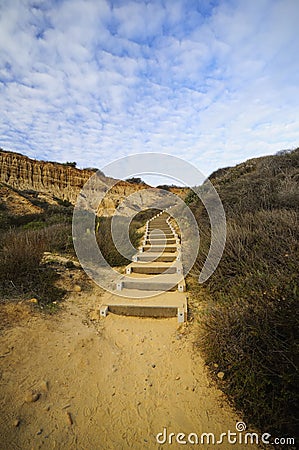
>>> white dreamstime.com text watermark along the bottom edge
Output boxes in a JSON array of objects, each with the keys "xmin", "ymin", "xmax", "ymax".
[{"xmin": 156, "ymin": 422, "xmax": 295, "ymax": 446}]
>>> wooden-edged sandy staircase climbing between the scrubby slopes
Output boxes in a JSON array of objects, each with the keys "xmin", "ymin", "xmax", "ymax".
[{"xmin": 100, "ymin": 210, "xmax": 187, "ymax": 322}]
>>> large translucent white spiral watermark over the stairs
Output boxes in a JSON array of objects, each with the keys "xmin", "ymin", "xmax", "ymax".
[{"xmin": 73, "ymin": 153, "xmax": 226, "ymax": 298}]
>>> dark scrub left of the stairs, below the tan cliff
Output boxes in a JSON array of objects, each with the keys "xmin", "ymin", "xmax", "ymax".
[{"xmin": 0, "ymin": 174, "xmax": 157, "ymax": 306}]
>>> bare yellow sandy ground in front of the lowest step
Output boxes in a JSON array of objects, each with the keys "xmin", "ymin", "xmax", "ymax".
[{"xmin": 0, "ymin": 288, "xmax": 256, "ymax": 450}]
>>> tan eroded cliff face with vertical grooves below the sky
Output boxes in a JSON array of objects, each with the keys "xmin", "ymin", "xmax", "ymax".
[{"xmin": 0, "ymin": 149, "xmax": 190, "ymax": 216}]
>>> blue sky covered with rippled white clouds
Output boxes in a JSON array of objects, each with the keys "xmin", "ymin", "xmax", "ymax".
[{"xmin": 0, "ymin": 0, "xmax": 299, "ymax": 183}]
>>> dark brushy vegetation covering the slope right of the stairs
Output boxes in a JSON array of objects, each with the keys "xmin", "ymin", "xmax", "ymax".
[{"xmin": 186, "ymin": 149, "xmax": 299, "ymax": 437}]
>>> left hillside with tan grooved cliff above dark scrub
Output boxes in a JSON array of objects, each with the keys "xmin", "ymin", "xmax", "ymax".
[{"xmin": 0, "ymin": 150, "xmax": 186, "ymax": 305}]
